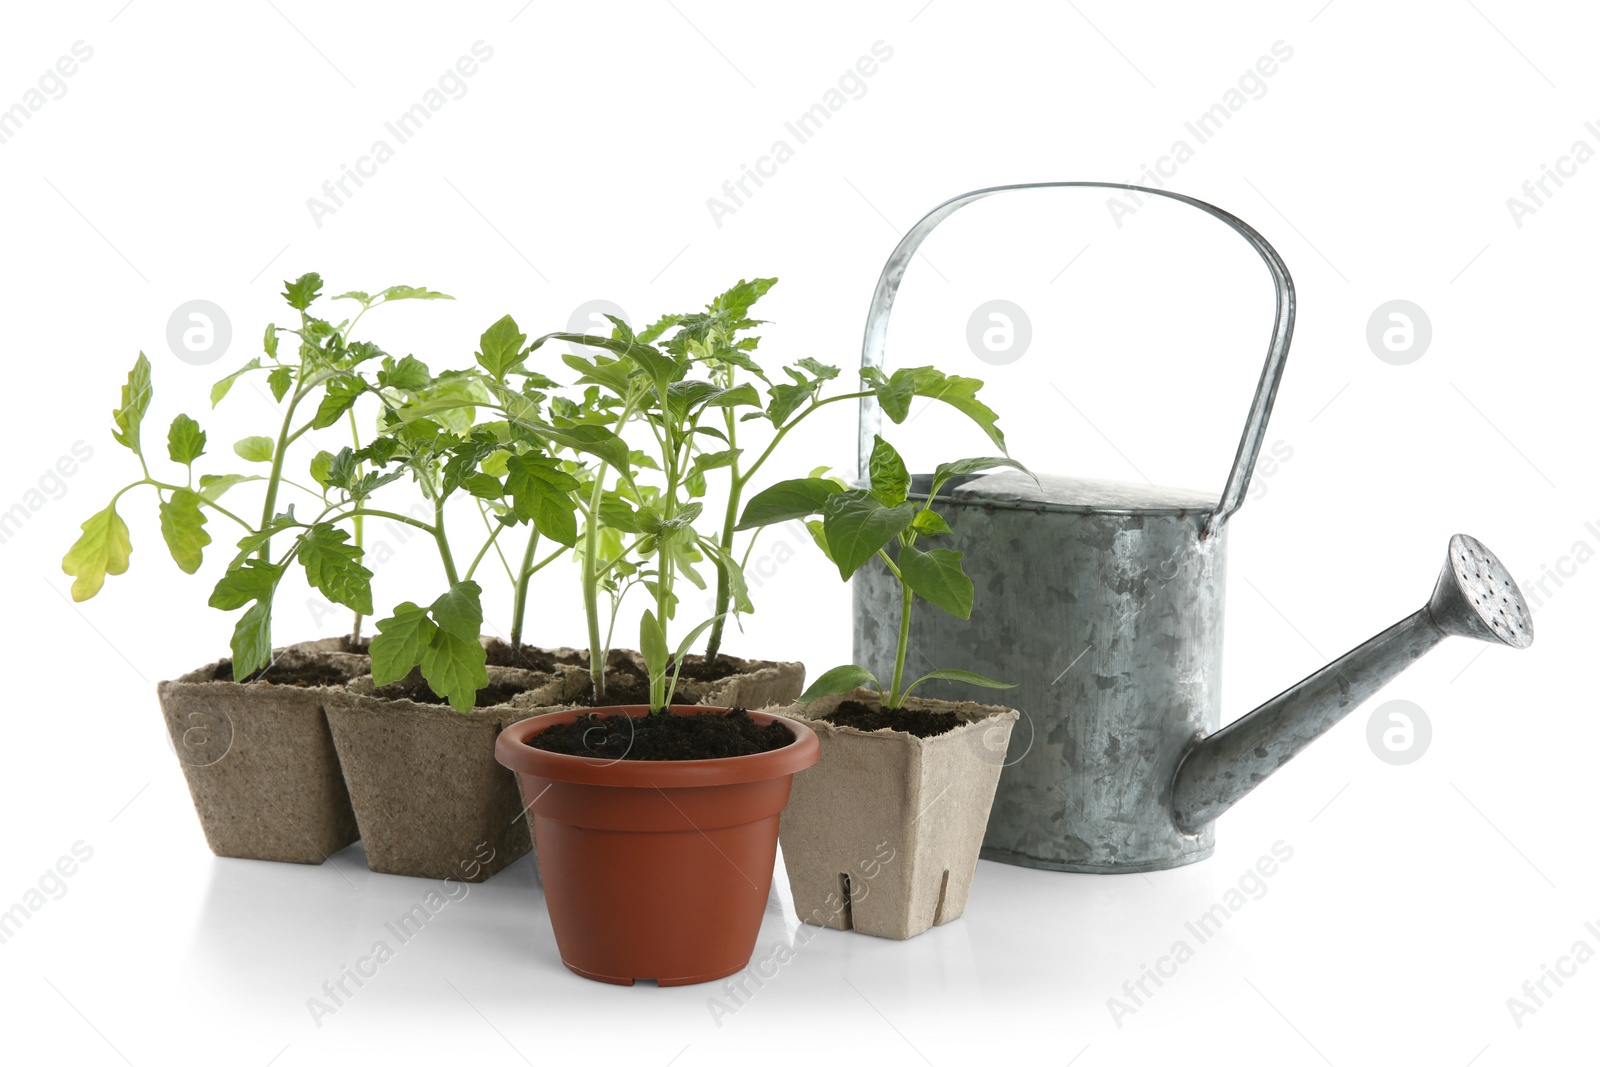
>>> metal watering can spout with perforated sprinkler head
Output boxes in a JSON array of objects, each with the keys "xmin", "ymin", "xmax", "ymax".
[{"xmin": 1173, "ymin": 534, "xmax": 1533, "ymax": 833}]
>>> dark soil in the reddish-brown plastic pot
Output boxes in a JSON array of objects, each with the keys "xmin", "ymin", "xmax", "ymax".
[{"xmin": 528, "ymin": 707, "xmax": 795, "ymax": 760}]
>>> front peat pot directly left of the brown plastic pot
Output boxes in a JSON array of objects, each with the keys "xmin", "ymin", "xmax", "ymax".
[{"xmin": 328, "ymin": 667, "xmax": 563, "ymax": 881}]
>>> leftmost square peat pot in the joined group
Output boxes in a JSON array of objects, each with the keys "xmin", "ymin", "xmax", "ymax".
[{"xmin": 155, "ymin": 638, "xmax": 371, "ymax": 864}]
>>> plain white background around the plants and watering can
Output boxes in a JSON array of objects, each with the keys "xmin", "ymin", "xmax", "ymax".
[{"xmin": 0, "ymin": 0, "xmax": 1600, "ymax": 1067}]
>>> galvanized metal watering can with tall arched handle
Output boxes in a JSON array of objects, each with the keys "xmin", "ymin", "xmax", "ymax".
[{"xmin": 854, "ymin": 182, "xmax": 1533, "ymax": 873}]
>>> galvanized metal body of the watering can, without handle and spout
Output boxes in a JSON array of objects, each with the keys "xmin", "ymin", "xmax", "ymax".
[{"xmin": 854, "ymin": 472, "xmax": 1227, "ymax": 872}]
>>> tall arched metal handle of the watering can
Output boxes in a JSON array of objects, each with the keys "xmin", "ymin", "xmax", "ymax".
[{"xmin": 859, "ymin": 181, "xmax": 1294, "ymax": 536}]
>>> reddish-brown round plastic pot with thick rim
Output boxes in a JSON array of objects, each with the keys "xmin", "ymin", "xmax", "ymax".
[{"xmin": 494, "ymin": 704, "xmax": 818, "ymax": 985}]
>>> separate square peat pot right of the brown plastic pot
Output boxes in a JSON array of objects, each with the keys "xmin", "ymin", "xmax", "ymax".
[{"xmin": 781, "ymin": 689, "xmax": 1019, "ymax": 939}]
